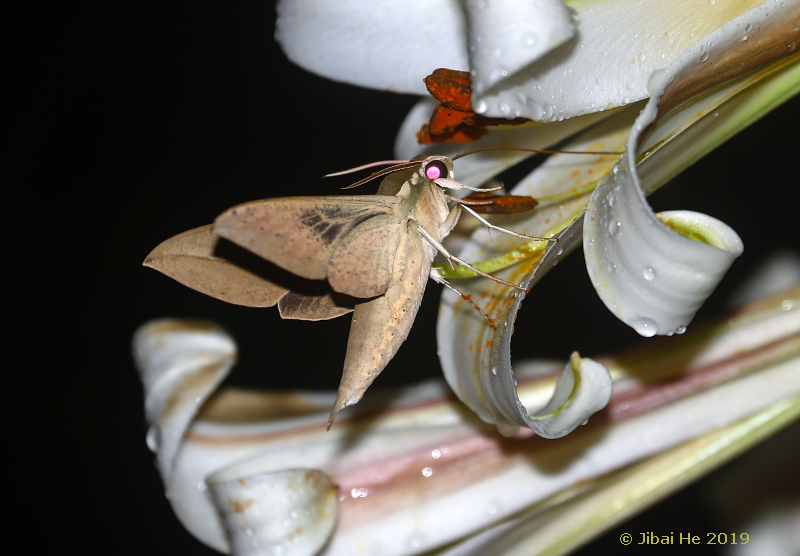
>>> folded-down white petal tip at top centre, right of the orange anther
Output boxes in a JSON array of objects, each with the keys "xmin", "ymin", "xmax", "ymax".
[{"xmin": 464, "ymin": 0, "xmax": 574, "ymax": 102}]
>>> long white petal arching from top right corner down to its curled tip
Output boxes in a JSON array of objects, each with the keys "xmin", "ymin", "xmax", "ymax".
[{"xmin": 584, "ymin": 2, "xmax": 800, "ymax": 336}]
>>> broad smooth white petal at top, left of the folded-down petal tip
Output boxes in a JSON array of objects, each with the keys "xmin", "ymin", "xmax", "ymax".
[{"xmin": 275, "ymin": 0, "xmax": 468, "ymax": 95}]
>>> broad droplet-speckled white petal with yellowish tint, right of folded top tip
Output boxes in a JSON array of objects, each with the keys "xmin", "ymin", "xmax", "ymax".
[{"xmin": 473, "ymin": 0, "xmax": 759, "ymax": 122}]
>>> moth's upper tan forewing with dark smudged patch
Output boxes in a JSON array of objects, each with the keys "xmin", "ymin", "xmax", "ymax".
[{"xmin": 214, "ymin": 195, "xmax": 400, "ymax": 280}]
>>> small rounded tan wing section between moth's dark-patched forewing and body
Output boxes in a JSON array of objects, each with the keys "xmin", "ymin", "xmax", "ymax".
[{"xmin": 328, "ymin": 215, "xmax": 407, "ymax": 297}]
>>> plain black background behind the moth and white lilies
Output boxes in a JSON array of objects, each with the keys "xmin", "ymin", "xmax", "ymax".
[{"xmin": 12, "ymin": 1, "xmax": 800, "ymax": 555}]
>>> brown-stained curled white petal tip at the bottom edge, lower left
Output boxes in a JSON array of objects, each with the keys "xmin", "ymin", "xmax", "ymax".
[{"xmin": 208, "ymin": 465, "xmax": 338, "ymax": 556}]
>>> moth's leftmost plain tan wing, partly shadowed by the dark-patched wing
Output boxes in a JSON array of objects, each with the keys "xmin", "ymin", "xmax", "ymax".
[{"xmin": 144, "ymin": 226, "xmax": 289, "ymax": 307}]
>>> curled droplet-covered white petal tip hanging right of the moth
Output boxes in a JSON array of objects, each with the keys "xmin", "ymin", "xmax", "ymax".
[{"xmin": 584, "ymin": 191, "xmax": 743, "ymax": 337}]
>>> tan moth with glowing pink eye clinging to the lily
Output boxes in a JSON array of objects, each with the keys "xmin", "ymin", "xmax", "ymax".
[{"xmin": 144, "ymin": 149, "xmax": 616, "ymax": 428}]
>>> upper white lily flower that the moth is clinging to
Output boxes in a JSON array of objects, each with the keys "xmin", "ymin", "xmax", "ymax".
[{"xmin": 277, "ymin": 1, "xmax": 800, "ymax": 436}]
